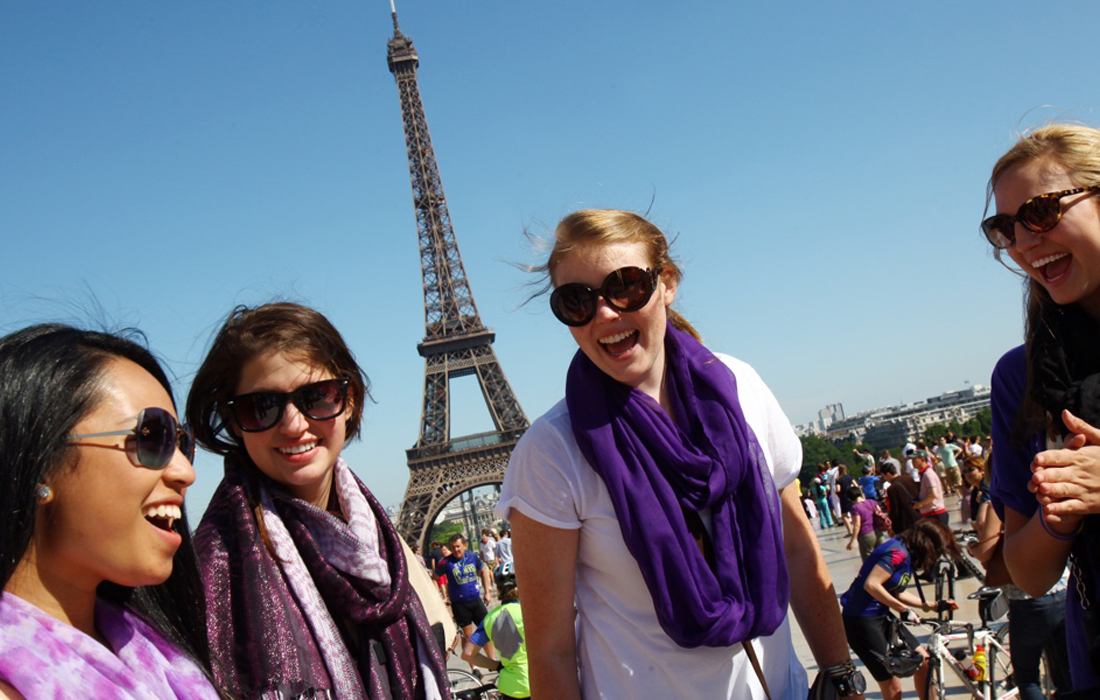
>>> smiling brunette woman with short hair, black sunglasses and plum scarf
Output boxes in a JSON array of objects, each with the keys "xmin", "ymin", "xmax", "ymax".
[{"xmin": 187, "ymin": 303, "xmax": 448, "ymax": 700}]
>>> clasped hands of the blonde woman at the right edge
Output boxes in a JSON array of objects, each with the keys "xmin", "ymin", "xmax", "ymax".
[{"xmin": 1027, "ymin": 411, "xmax": 1100, "ymax": 521}]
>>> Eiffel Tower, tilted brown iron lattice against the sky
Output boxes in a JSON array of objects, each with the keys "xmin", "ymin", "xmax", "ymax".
[{"xmin": 386, "ymin": 8, "xmax": 528, "ymax": 551}]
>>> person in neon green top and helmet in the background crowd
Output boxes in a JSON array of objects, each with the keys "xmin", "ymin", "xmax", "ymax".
[{"xmin": 462, "ymin": 577, "xmax": 531, "ymax": 700}]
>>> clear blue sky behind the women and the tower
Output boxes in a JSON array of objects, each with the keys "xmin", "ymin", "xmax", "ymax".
[{"xmin": 0, "ymin": 0, "xmax": 1100, "ymax": 516}]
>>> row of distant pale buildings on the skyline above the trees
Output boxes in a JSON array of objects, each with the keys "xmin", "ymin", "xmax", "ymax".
[{"xmin": 796, "ymin": 384, "xmax": 989, "ymax": 449}]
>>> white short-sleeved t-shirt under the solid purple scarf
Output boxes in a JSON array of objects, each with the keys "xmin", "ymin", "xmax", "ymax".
[{"xmin": 496, "ymin": 354, "xmax": 807, "ymax": 700}]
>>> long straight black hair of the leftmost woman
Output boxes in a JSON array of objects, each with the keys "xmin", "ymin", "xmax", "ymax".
[{"xmin": 0, "ymin": 324, "xmax": 210, "ymax": 676}]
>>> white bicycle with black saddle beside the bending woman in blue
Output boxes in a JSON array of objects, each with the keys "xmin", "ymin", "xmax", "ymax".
[{"xmin": 909, "ymin": 588, "xmax": 1049, "ymax": 700}]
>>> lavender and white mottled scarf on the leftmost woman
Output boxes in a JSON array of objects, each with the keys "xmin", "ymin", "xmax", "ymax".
[{"xmin": 0, "ymin": 593, "xmax": 218, "ymax": 700}]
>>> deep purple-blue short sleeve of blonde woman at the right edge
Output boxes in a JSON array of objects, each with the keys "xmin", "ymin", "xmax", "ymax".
[{"xmin": 990, "ymin": 346, "xmax": 1040, "ymax": 519}]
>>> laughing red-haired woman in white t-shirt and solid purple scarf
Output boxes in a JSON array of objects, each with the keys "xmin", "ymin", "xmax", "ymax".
[{"xmin": 498, "ymin": 210, "xmax": 862, "ymax": 700}]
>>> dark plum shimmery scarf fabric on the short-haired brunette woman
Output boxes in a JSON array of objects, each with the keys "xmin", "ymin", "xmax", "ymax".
[{"xmin": 195, "ymin": 458, "xmax": 449, "ymax": 700}]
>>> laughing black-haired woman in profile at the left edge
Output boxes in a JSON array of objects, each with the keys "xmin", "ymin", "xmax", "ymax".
[{"xmin": 0, "ymin": 325, "xmax": 218, "ymax": 700}]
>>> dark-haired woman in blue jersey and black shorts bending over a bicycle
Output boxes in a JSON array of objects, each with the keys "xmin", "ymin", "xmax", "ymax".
[{"xmin": 840, "ymin": 518, "xmax": 961, "ymax": 700}]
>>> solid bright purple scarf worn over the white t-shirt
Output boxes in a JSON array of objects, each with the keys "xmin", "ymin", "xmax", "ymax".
[{"xmin": 565, "ymin": 324, "xmax": 790, "ymax": 647}]
